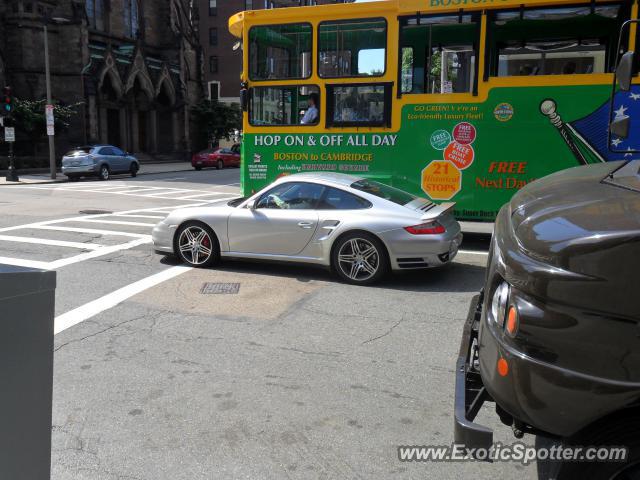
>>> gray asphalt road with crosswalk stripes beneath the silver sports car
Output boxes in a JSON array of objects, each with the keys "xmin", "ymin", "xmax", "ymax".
[{"xmin": 0, "ymin": 169, "xmax": 535, "ymax": 480}]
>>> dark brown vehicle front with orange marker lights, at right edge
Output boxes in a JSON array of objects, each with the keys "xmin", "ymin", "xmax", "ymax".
[{"xmin": 455, "ymin": 26, "xmax": 640, "ymax": 480}]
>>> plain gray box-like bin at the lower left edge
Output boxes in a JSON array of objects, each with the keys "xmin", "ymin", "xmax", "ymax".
[{"xmin": 0, "ymin": 265, "xmax": 56, "ymax": 480}]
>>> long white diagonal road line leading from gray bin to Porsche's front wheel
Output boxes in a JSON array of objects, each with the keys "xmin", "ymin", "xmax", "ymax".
[{"xmin": 53, "ymin": 265, "xmax": 191, "ymax": 335}]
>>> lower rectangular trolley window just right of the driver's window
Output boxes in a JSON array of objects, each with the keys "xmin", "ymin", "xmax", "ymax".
[{"xmin": 327, "ymin": 83, "xmax": 391, "ymax": 127}]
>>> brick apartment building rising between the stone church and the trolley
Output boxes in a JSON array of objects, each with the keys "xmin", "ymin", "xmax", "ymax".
[{"xmin": 198, "ymin": 0, "xmax": 354, "ymax": 102}]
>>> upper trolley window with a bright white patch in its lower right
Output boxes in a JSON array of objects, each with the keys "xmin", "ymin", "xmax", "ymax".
[{"xmin": 318, "ymin": 18, "xmax": 387, "ymax": 78}]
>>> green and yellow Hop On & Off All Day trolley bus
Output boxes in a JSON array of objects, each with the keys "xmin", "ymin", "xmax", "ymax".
[{"xmin": 229, "ymin": 0, "xmax": 640, "ymax": 221}]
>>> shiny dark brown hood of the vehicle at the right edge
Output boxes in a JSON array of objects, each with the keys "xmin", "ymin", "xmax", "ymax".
[{"xmin": 510, "ymin": 161, "xmax": 640, "ymax": 266}]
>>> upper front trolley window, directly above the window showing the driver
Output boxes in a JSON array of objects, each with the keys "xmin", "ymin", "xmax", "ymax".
[{"xmin": 249, "ymin": 23, "xmax": 312, "ymax": 80}]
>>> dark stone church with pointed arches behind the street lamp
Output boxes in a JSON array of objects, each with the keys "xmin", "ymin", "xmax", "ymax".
[{"xmin": 0, "ymin": 0, "xmax": 203, "ymax": 159}]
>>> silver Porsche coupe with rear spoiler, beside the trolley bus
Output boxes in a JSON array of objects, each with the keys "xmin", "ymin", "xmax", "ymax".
[{"xmin": 153, "ymin": 172, "xmax": 462, "ymax": 285}]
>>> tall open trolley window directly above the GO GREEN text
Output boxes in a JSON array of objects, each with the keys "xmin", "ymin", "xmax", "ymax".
[{"xmin": 400, "ymin": 15, "xmax": 478, "ymax": 93}]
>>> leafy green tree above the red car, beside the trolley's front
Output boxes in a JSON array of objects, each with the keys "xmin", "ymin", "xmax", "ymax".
[{"xmin": 191, "ymin": 100, "xmax": 242, "ymax": 146}]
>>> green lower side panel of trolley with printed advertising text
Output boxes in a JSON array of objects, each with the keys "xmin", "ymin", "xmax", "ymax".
[{"xmin": 242, "ymin": 85, "xmax": 640, "ymax": 221}]
